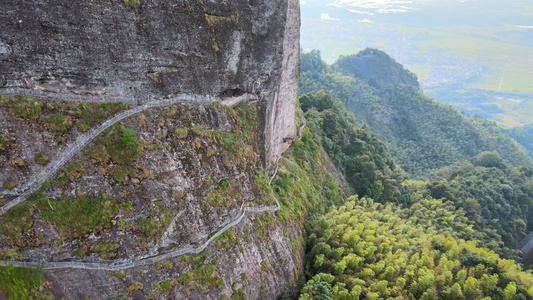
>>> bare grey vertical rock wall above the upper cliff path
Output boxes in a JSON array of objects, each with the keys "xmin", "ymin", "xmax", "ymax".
[{"xmin": 0, "ymin": 0, "xmax": 299, "ymax": 161}]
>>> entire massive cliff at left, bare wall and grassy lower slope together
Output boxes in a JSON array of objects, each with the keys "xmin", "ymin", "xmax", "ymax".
[{"xmin": 0, "ymin": 0, "xmax": 303, "ymax": 299}]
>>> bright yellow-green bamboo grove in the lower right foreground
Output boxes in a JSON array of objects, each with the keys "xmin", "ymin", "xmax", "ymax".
[{"xmin": 300, "ymin": 197, "xmax": 533, "ymax": 300}]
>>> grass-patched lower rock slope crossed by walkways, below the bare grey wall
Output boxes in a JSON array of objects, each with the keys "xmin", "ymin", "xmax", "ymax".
[{"xmin": 0, "ymin": 97, "xmax": 303, "ymax": 299}]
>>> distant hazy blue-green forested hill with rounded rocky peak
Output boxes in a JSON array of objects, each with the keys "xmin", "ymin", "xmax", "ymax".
[{"xmin": 300, "ymin": 49, "xmax": 533, "ymax": 178}]
